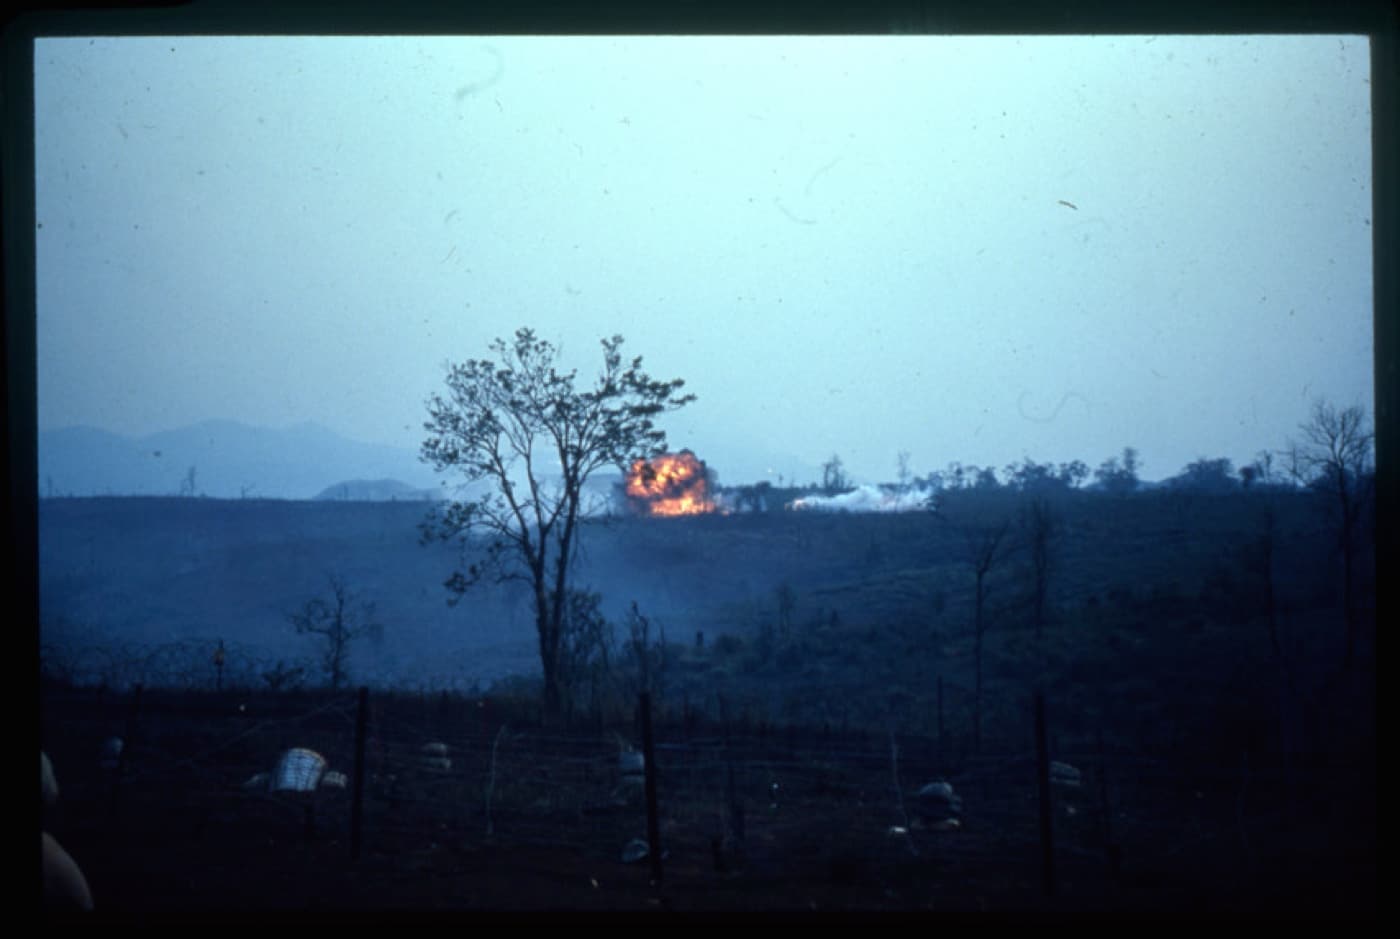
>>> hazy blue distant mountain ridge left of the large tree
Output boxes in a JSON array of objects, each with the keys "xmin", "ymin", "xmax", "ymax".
[{"xmin": 38, "ymin": 420, "xmax": 440, "ymax": 500}]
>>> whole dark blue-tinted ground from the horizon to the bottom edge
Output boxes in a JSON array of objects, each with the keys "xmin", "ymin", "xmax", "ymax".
[{"xmin": 39, "ymin": 491, "xmax": 1378, "ymax": 919}]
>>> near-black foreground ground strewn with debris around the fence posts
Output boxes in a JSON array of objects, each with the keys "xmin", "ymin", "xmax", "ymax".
[{"xmin": 45, "ymin": 689, "xmax": 1376, "ymax": 922}]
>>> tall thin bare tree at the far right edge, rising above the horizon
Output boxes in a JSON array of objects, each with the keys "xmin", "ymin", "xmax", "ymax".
[{"xmin": 1285, "ymin": 399, "xmax": 1375, "ymax": 668}]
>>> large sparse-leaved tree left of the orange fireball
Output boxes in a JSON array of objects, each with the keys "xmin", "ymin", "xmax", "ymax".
[{"xmin": 421, "ymin": 329, "xmax": 694, "ymax": 716}]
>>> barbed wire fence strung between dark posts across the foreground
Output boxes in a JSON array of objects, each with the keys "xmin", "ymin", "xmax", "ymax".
[{"xmin": 38, "ymin": 671, "xmax": 1336, "ymax": 901}]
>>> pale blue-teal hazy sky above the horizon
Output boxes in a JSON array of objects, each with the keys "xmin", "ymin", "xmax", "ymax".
[{"xmin": 35, "ymin": 35, "xmax": 1373, "ymax": 483}]
